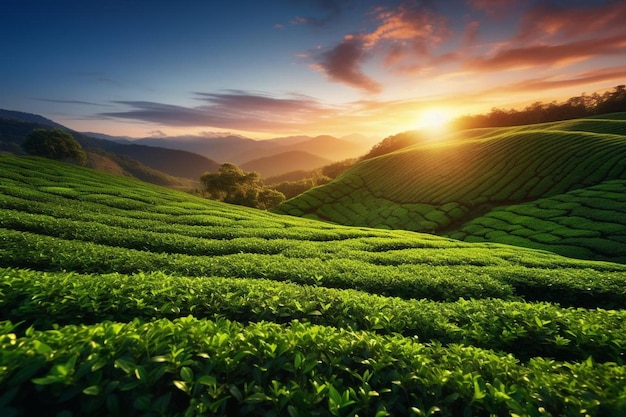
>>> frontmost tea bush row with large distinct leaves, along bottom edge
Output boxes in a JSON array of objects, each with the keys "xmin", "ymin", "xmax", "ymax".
[{"xmin": 0, "ymin": 317, "xmax": 626, "ymax": 417}]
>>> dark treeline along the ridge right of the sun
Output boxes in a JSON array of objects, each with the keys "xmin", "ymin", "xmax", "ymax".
[{"xmin": 453, "ymin": 85, "xmax": 626, "ymax": 129}]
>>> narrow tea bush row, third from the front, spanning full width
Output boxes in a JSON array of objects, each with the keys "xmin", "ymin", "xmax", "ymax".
[{"xmin": 0, "ymin": 229, "xmax": 626, "ymax": 308}]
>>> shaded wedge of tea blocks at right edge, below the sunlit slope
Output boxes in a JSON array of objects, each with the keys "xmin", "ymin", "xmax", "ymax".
[{"xmin": 448, "ymin": 180, "xmax": 626, "ymax": 263}]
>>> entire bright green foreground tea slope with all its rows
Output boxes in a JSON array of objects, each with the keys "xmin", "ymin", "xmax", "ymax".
[{"xmin": 0, "ymin": 155, "xmax": 626, "ymax": 416}]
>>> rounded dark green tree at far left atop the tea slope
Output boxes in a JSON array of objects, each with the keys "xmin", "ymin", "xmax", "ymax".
[{"xmin": 22, "ymin": 129, "xmax": 87, "ymax": 165}]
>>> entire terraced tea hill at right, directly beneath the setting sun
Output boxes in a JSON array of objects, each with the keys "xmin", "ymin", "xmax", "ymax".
[{"xmin": 276, "ymin": 113, "xmax": 626, "ymax": 262}]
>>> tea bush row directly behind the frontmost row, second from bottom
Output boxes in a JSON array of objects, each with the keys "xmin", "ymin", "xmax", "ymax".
[{"xmin": 0, "ymin": 269, "xmax": 626, "ymax": 362}]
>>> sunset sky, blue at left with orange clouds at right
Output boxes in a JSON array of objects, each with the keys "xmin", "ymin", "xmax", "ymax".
[{"xmin": 0, "ymin": 0, "xmax": 626, "ymax": 139}]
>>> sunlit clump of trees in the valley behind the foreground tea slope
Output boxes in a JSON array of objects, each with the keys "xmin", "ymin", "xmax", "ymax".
[{"xmin": 200, "ymin": 163, "xmax": 285, "ymax": 209}]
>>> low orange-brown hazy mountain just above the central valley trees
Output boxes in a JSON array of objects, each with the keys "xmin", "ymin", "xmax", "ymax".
[{"xmin": 241, "ymin": 151, "xmax": 332, "ymax": 178}]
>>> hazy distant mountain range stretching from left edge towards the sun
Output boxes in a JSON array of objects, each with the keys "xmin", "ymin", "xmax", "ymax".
[{"xmin": 0, "ymin": 110, "xmax": 375, "ymax": 181}]
